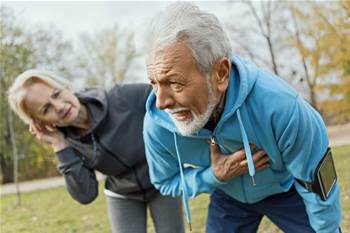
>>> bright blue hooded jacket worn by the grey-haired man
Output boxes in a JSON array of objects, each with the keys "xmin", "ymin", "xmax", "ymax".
[{"xmin": 144, "ymin": 57, "xmax": 341, "ymax": 233}]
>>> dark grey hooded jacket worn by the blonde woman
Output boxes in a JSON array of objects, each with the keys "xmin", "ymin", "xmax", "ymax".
[{"xmin": 57, "ymin": 84, "xmax": 157, "ymax": 204}]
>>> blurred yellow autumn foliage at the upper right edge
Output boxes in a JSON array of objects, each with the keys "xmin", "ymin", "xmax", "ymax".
[{"xmin": 290, "ymin": 1, "xmax": 350, "ymax": 123}]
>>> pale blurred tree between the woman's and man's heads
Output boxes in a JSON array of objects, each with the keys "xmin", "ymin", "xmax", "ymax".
[{"xmin": 75, "ymin": 25, "xmax": 139, "ymax": 88}]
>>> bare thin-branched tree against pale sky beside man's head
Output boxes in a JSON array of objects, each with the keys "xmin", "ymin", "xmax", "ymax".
[{"xmin": 228, "ymin": 1, "xmax": 294, "ymax": 78}]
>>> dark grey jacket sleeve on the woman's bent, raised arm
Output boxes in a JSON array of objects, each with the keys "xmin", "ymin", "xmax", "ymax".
[{"xmin": 56, "ymin": 146, "xmax": 98, "ymax": 204}]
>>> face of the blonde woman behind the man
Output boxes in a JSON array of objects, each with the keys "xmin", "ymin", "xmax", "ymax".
[{"xmin": 23, "ymin": 81, "xmax": 80, "ymax": 127}]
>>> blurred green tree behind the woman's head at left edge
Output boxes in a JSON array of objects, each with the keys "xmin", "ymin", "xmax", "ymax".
[{"xmin": 0, "ymin": 5, "xmax": 71, "ymax": 183}]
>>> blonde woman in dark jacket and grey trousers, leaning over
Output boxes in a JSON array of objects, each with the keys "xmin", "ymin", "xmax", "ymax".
[{"xmin": 8, "ymin": 70, "xmax": 184, "ymax": 233}]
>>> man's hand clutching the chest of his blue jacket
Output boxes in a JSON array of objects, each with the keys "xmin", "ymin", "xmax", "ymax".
[{"xmin": 210, "ymin": 144, "xmax": 269, "ymax": 181}]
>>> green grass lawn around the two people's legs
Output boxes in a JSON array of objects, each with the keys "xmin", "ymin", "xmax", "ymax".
[{"xmin": 0, "ymin": 145, "xmax": 350, "ymax": 233}]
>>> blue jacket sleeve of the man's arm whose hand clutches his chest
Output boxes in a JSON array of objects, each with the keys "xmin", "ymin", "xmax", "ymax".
[{"xmin": 143, "ymin": 114, "xmax": 223, "ymax": 198}]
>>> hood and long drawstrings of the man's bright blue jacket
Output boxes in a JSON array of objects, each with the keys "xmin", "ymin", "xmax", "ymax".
[{"xmin": 146, "ymin": 56, "xmax": 258, "ymax": 228}]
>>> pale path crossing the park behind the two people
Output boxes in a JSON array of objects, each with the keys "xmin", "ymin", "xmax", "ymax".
[{"xmin": 0, "ymin": 123, "xmax": 350, "ymax": 196}]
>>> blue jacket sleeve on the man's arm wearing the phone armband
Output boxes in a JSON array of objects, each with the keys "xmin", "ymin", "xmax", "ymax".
[{"xmin": 272, "ymin": 97, "xmax": 341, "ymax": 233}]
